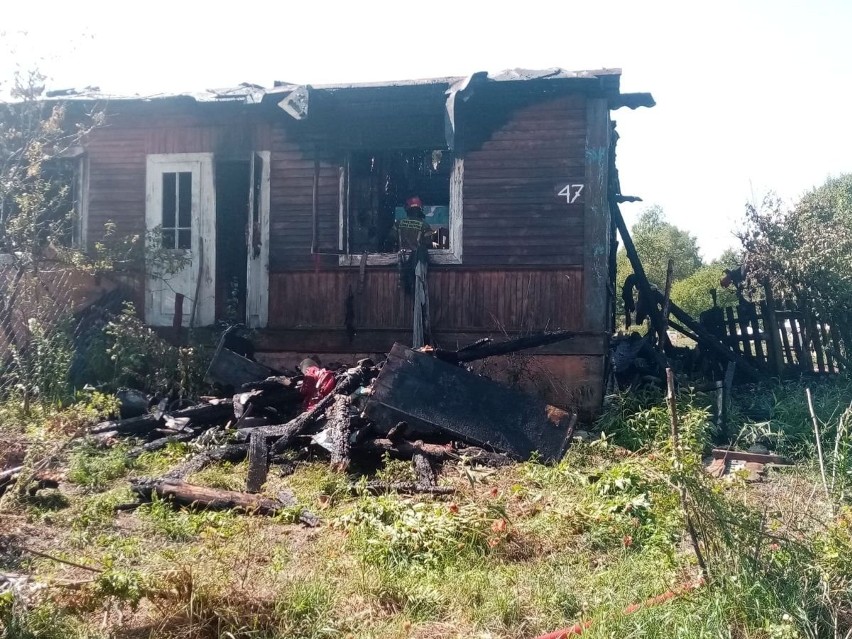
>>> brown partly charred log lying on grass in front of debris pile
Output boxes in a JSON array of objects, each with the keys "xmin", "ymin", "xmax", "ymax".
[{"xmin": 130, "ymin": 479, "xmax": 292, "ymax": 515}]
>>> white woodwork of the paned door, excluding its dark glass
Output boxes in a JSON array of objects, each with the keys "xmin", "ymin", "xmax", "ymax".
[{"xmin": 145, "ymin": 153, "xmax": 216, "ymax": 326}]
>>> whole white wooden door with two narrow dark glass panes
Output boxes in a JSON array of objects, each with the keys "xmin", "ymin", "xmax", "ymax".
[{"xmin": 145, "ymin": 153, "xmax": 216, "ymax": 326}]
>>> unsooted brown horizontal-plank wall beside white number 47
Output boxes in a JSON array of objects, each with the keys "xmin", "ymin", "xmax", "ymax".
[{"xmin": 463, "ymin": 96, "xmax": 586, "ymax": 266}]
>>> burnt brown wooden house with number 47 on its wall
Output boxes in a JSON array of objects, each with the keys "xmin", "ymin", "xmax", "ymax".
[{"xmin": 62, "ymin": 69, "xmax": 653, "ymax": 412}]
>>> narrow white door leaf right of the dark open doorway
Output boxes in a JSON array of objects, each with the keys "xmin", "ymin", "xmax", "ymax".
[{"xmin": 246, "ymin": 151, "xmax": 270, "ymax": 328}]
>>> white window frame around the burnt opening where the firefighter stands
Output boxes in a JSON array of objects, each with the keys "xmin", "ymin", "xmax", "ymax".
[{"xmin": 338, "ymin": 158, "xmax": 464, "ymax": 266}]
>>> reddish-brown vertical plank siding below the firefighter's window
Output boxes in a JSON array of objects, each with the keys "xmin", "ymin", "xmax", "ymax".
[{"xmin": 269, "ymin": 267, "xmax": 583, "ymax": 333}]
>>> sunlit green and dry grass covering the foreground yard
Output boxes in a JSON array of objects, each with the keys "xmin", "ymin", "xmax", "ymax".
[{"xmin": 0, "ymin": 384, "xmax": 852, "ymax": 639}]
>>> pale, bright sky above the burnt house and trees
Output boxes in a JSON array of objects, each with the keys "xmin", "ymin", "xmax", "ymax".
[{"xmin": 0, "ymin": 0, "xmax": 852, "ymax": 258}]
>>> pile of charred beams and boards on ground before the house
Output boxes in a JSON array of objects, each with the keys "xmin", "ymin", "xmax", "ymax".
[{"xmin": 81, "ymin": 331, "xmax": 577, "ymax": 525}]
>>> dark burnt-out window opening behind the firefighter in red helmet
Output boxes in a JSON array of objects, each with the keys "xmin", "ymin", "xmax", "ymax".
[{"xmin": 348, "ymin": 149, "xmax": 454, "ymax": 254}]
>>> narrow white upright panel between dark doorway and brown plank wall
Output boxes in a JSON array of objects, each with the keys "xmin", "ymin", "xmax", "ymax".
[{"xmin": 246, "ymin": 151, "xmax": 272, "ymax": 328}]
